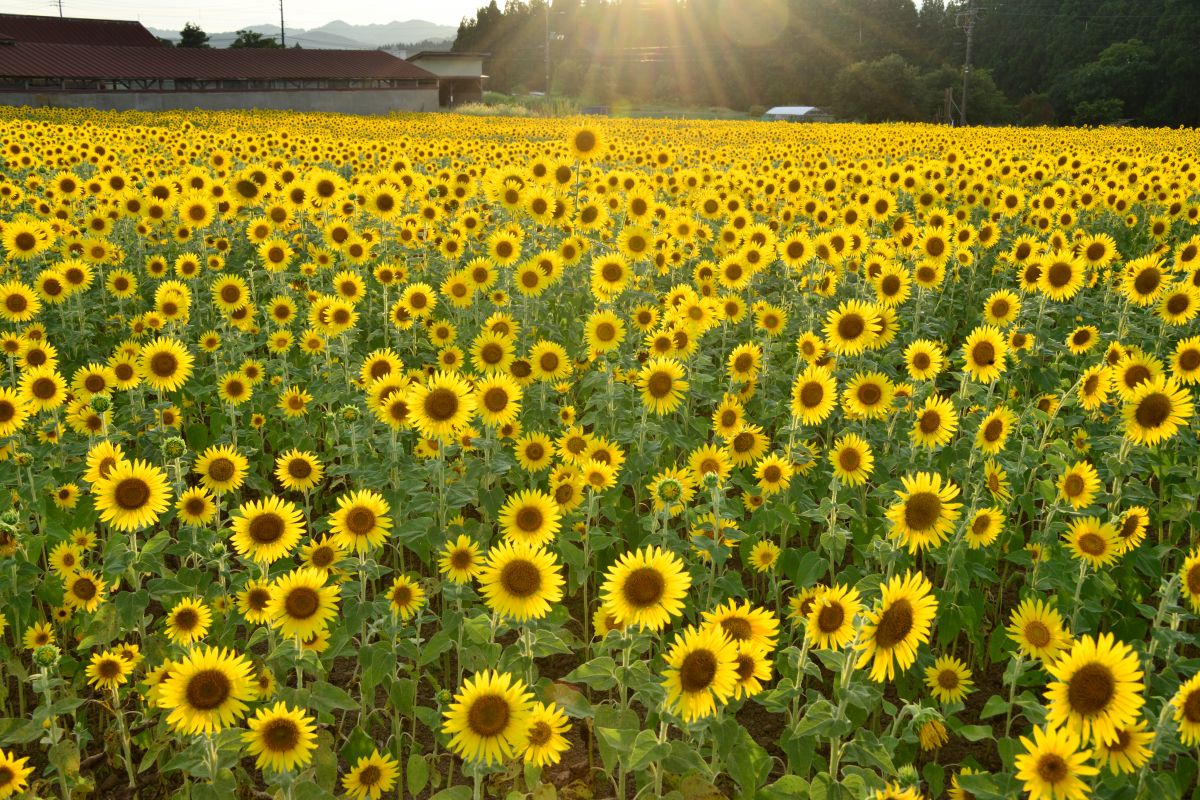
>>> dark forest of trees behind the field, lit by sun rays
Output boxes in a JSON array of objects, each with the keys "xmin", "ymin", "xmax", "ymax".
[{"xmin": 455, "ymin": 0, "xmax": 1200, "ymax": 125}]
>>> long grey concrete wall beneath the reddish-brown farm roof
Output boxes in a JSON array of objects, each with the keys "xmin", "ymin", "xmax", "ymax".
[{"xmin": 0, "ymin": 88, "xmax": 438, "ymax": 114}]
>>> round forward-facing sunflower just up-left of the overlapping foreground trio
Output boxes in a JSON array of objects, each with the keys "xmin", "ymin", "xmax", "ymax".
[{"xmin": 600, "ymin": 547, "xmax": 691, "ymax": 631}]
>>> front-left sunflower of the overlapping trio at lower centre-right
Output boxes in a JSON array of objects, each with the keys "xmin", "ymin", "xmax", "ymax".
[{"xmin": 662, "ymin": 626, "xmax": 738, "ymax": 722}]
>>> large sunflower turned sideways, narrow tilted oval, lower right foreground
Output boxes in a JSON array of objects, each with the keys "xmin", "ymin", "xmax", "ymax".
[{"xmin": 857, "ymin": 571, "xmax": 937, "ymax": 682}]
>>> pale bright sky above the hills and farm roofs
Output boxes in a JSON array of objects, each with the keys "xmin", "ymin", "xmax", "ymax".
[{"xmin": 0, "ymin": 0, "xmax": 487, "ymax": 32}]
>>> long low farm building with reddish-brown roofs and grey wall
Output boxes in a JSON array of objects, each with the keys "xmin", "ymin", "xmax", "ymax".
[{"xmin": 0, "ymin": 14, "xmax": 438, "ymax": 114}]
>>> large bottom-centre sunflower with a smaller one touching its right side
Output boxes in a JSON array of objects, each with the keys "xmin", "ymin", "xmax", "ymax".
[{"xmin": 442, "ymin": 669, "xmax": 533, "ymax": 764}]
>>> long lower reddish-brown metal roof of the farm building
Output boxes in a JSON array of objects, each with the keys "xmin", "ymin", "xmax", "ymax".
[{"xmin": 0, "ymin": 42, "xmax": 437, "ymax": 80}]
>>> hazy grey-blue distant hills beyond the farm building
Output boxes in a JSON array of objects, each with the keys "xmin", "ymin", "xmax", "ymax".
[{"xmin": 150, "ymin": 19, "xmax": 458, "ymax": 50}]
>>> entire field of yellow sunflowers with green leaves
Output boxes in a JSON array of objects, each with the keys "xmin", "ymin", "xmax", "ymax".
[{"xmin": 0, "ymin": 108, "xmax": 1200, "ymax": 800}]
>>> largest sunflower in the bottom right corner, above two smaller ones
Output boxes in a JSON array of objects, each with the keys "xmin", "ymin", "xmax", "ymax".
[{"xmin": 1046, "ymin": 633, "xmax": 1144, "ymax": 744}]
